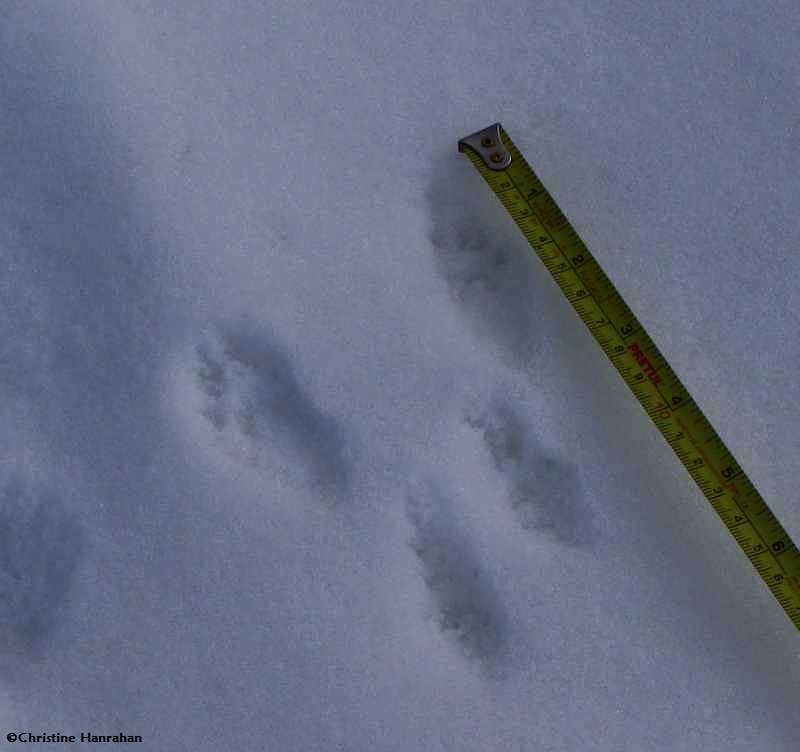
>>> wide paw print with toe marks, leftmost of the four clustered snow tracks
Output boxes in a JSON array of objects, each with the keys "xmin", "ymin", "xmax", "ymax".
[{"xmin": 193, "ymin": 319, "xmax": 350, "ymax": 494}]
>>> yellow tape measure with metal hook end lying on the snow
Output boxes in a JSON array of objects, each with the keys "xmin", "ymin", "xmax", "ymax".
[{"xmin": 458, "ymin": 123, "xmax": 800, "ymax": 629}]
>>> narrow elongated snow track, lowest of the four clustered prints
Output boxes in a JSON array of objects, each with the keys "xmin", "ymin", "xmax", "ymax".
[{"xmin": 406, "ymin": 484, "xmax": 508, "ymax": 673}]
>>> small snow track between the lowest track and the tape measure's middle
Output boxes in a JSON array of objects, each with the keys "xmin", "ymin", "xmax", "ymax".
[{"xmin": 467, "ymin": 399, "xmax": 594, "ymax": 547}]
